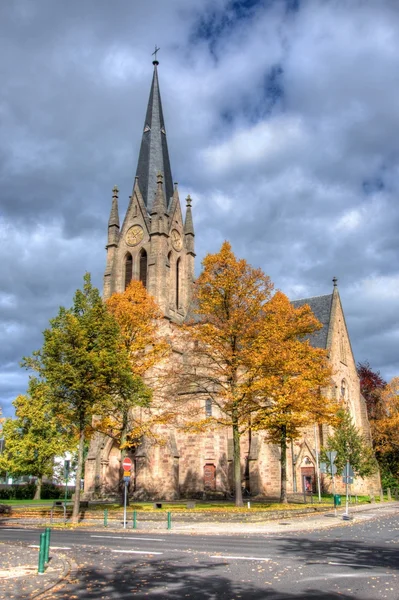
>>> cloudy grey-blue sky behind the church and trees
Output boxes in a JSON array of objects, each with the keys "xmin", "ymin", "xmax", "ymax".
[{"xmin": 0, "ymin": 0, "xmax": 399, "ymax": 415}]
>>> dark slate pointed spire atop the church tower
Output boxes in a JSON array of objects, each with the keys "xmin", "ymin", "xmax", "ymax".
[{"xmin": 136, "ymin": 60, "xmax": 173, "ymax": 213}]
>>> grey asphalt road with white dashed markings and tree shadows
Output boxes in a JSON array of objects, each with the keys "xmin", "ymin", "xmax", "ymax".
[{"xmin": 0, "ymin": 509, "xmax": 399, "ymax": 600}]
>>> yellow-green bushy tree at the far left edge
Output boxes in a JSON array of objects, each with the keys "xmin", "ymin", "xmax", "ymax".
[{"xmin": 0, "ymin": 378, "xmax": 74, "ymax": 500}]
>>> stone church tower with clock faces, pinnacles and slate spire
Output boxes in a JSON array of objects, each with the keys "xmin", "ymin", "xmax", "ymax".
[{"xmin": 104, "ymin": 60, "xmax": 195, "ymax": 322}]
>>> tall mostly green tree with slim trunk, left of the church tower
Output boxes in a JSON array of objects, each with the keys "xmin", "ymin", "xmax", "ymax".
[{"xmin": 24, "ymin": 274, "xmax": 142, "ymax": 522}]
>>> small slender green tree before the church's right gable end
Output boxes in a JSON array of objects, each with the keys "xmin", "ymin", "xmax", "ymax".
[{"xmin": 321, "ymin": 408, "xmax": 378, "ymax": 478}]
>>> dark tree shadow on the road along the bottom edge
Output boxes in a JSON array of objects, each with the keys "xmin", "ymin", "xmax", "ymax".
[{"xmin": 50, "ymin": 559, "xmax": 368, "ymax": 600}]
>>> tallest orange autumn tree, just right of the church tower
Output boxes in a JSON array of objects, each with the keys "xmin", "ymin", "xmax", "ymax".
[{"xmin": 176, "ymin": 242, "xmax": 273, "ymax": 506}]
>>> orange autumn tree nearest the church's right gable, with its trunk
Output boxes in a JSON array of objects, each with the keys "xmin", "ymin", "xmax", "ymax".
[{"xmin": 250, "ymin": 292, "xmax": 337, "ymax": 503}]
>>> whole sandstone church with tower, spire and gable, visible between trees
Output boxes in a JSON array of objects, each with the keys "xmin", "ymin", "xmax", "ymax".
[{"xmin": 84, "ymin": 60, "xmax": 379, "ymax": 500}]
